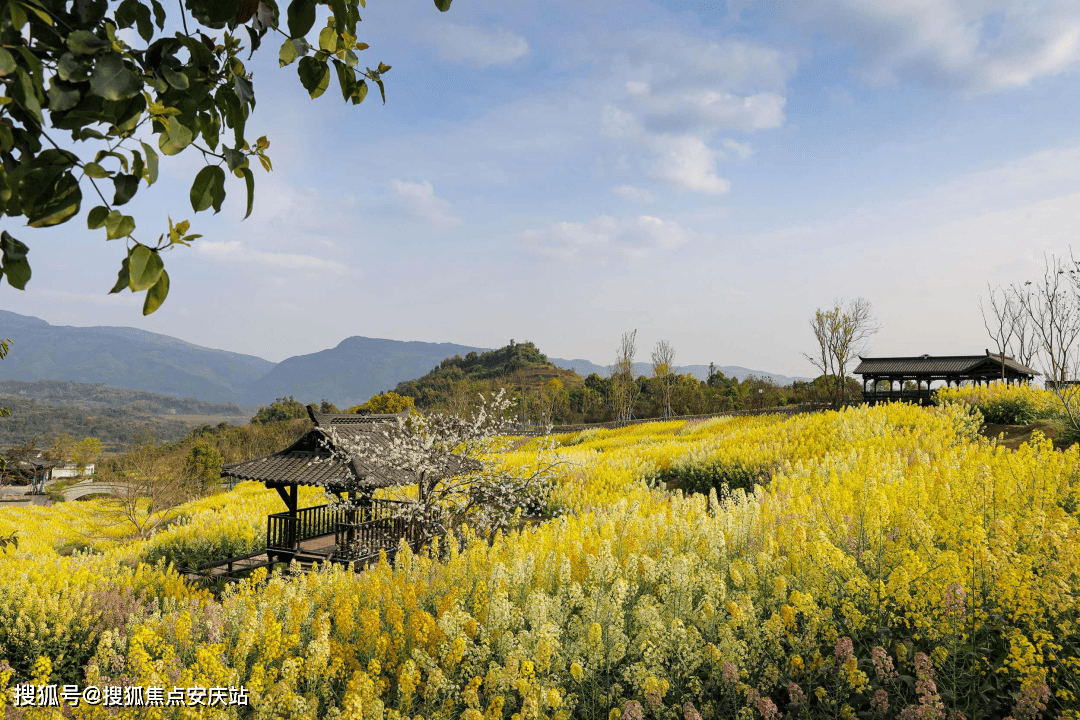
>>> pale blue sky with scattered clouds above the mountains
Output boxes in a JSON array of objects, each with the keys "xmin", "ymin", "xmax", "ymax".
[{"xmin": 6, "ymin": 0, "xmax": 1080, "ymax": 375}]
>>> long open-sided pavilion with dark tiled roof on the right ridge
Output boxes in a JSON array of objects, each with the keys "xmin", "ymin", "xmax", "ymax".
[{"xmin": 854, "ymin": 350, "xmax": 1039, "ymax": 405}]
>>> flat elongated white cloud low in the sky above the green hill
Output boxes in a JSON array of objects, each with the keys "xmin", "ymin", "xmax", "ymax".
[{"xmin": 519, "ymin": 215, "xmax": 696, "ymax": 259}]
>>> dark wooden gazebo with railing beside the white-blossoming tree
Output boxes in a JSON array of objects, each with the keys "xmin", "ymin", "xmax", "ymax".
[{"xmin": 221, "ymin": 408, "xmax": 426, "ymax": 567}]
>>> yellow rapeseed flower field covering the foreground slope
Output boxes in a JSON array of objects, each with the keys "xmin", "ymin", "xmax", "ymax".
[{"xmin": 0, "ymin": 404, "xmax": 1080, "ymax": 720}]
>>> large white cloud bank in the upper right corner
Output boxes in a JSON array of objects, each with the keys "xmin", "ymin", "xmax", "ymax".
[{"xmin": 792, "ymin": 0, "xmax": 1080, "ymax": 93}]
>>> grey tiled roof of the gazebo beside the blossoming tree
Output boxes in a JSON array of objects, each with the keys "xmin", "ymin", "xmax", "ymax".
[{"xmin": 221, "ymin": 408, "xmax": 425, "ymax": 490}]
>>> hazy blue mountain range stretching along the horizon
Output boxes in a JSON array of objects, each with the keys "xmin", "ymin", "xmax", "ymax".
[{"xmin": 0, "ymin": 310, "xmax": 799, "ymax": 407}]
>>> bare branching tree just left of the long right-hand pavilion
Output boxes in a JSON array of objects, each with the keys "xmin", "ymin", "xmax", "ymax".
[{"xmin": 804, "ymin": 298, "xmax": 881, "ymax": 405}]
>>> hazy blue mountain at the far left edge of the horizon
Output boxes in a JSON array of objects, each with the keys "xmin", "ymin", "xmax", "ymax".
[{"xmin": 0, "ymin": 310, "xmax": 274, "ymax": 403}]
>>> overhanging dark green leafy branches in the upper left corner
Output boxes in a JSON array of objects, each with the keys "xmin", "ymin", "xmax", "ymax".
[{"xmin": 0, "ymin": 0, "xmax": 450, "ymax": 314}]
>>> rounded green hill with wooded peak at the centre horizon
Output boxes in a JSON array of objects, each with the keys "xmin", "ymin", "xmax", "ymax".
[{"xmin": 395, "ymin": 340, "xmax": 583, "ymax": 407}]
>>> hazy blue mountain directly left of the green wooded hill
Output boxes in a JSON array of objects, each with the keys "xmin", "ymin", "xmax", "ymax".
[{"xmin": 243, "ymin": 336, "xmax": 483, "ymax": 407}]
